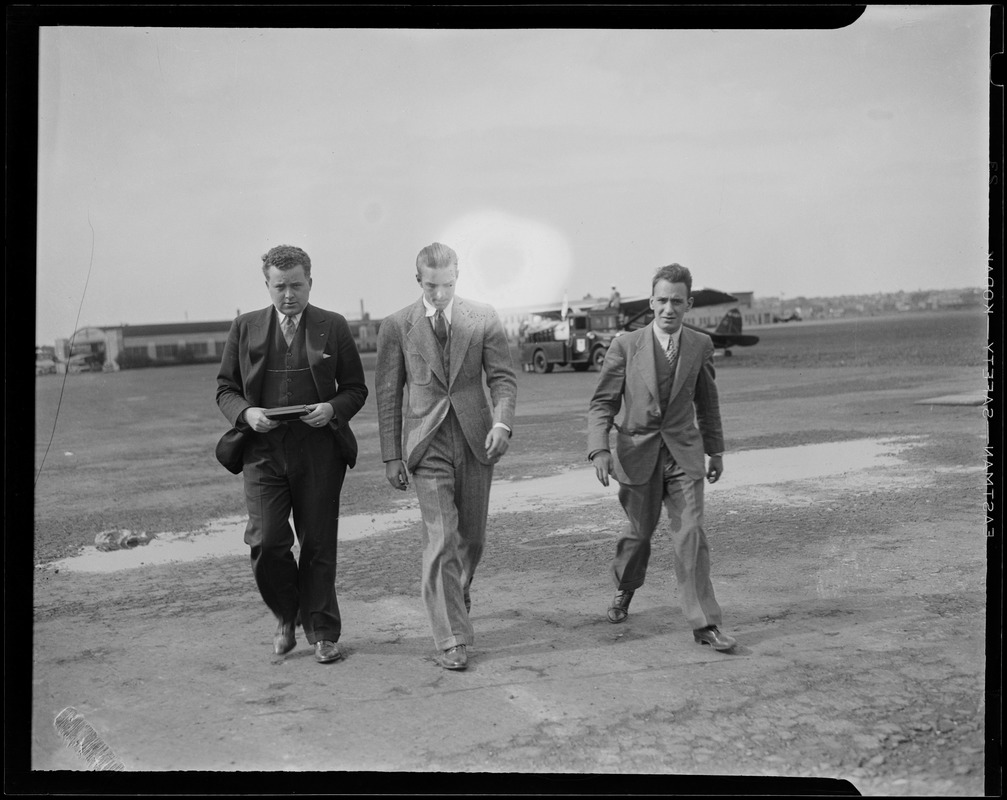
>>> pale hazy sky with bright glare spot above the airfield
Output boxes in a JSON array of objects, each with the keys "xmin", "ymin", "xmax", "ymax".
[{"xmin": 35, "ymin": 6, "xmax": 990, "ymax": 344}]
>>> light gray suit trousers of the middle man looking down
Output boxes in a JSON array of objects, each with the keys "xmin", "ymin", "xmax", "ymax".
[{"xmin": 413, "ymin": 410, "xmax": 493, "ymax": 650}]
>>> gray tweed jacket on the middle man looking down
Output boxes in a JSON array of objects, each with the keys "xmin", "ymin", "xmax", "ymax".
[{"xmin": 375, "ymin": 295, "xmax": 518, "ymax": 471}]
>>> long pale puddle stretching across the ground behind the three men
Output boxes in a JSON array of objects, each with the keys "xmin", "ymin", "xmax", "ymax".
[{"xmin": 43, "ymin": 437, "xmax": 918, "ymax": 572}]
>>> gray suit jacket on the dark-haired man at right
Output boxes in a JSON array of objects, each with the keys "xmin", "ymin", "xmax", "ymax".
[{"xmin": 587, "ymin": 325, "xmax": 724, "ymax": 485}]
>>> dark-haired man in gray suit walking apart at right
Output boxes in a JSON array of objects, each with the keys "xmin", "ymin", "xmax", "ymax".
[{"xmin": 588, "ymin": 264, "xmax": 735, "ymax": 650}]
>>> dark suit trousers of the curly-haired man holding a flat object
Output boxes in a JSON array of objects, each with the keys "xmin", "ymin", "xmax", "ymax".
[{"xmin": 244, "ymin": 422, "xmax": 346, "ymax": 644}]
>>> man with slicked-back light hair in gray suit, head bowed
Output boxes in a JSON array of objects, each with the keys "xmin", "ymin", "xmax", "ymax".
[{"xmin": 376, "ymin": 243, "xmax": 518, "ymax": 669}]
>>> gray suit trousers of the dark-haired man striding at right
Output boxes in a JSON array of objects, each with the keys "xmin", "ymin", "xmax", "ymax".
[{"xmin": 612, "ymin": 448, "xmax": 721, "ymax": 630}]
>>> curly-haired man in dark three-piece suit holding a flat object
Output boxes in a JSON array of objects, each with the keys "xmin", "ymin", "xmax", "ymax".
[{"xmin": 217, "ymin": 245, "xmax": 368, "ymax": 663}]
